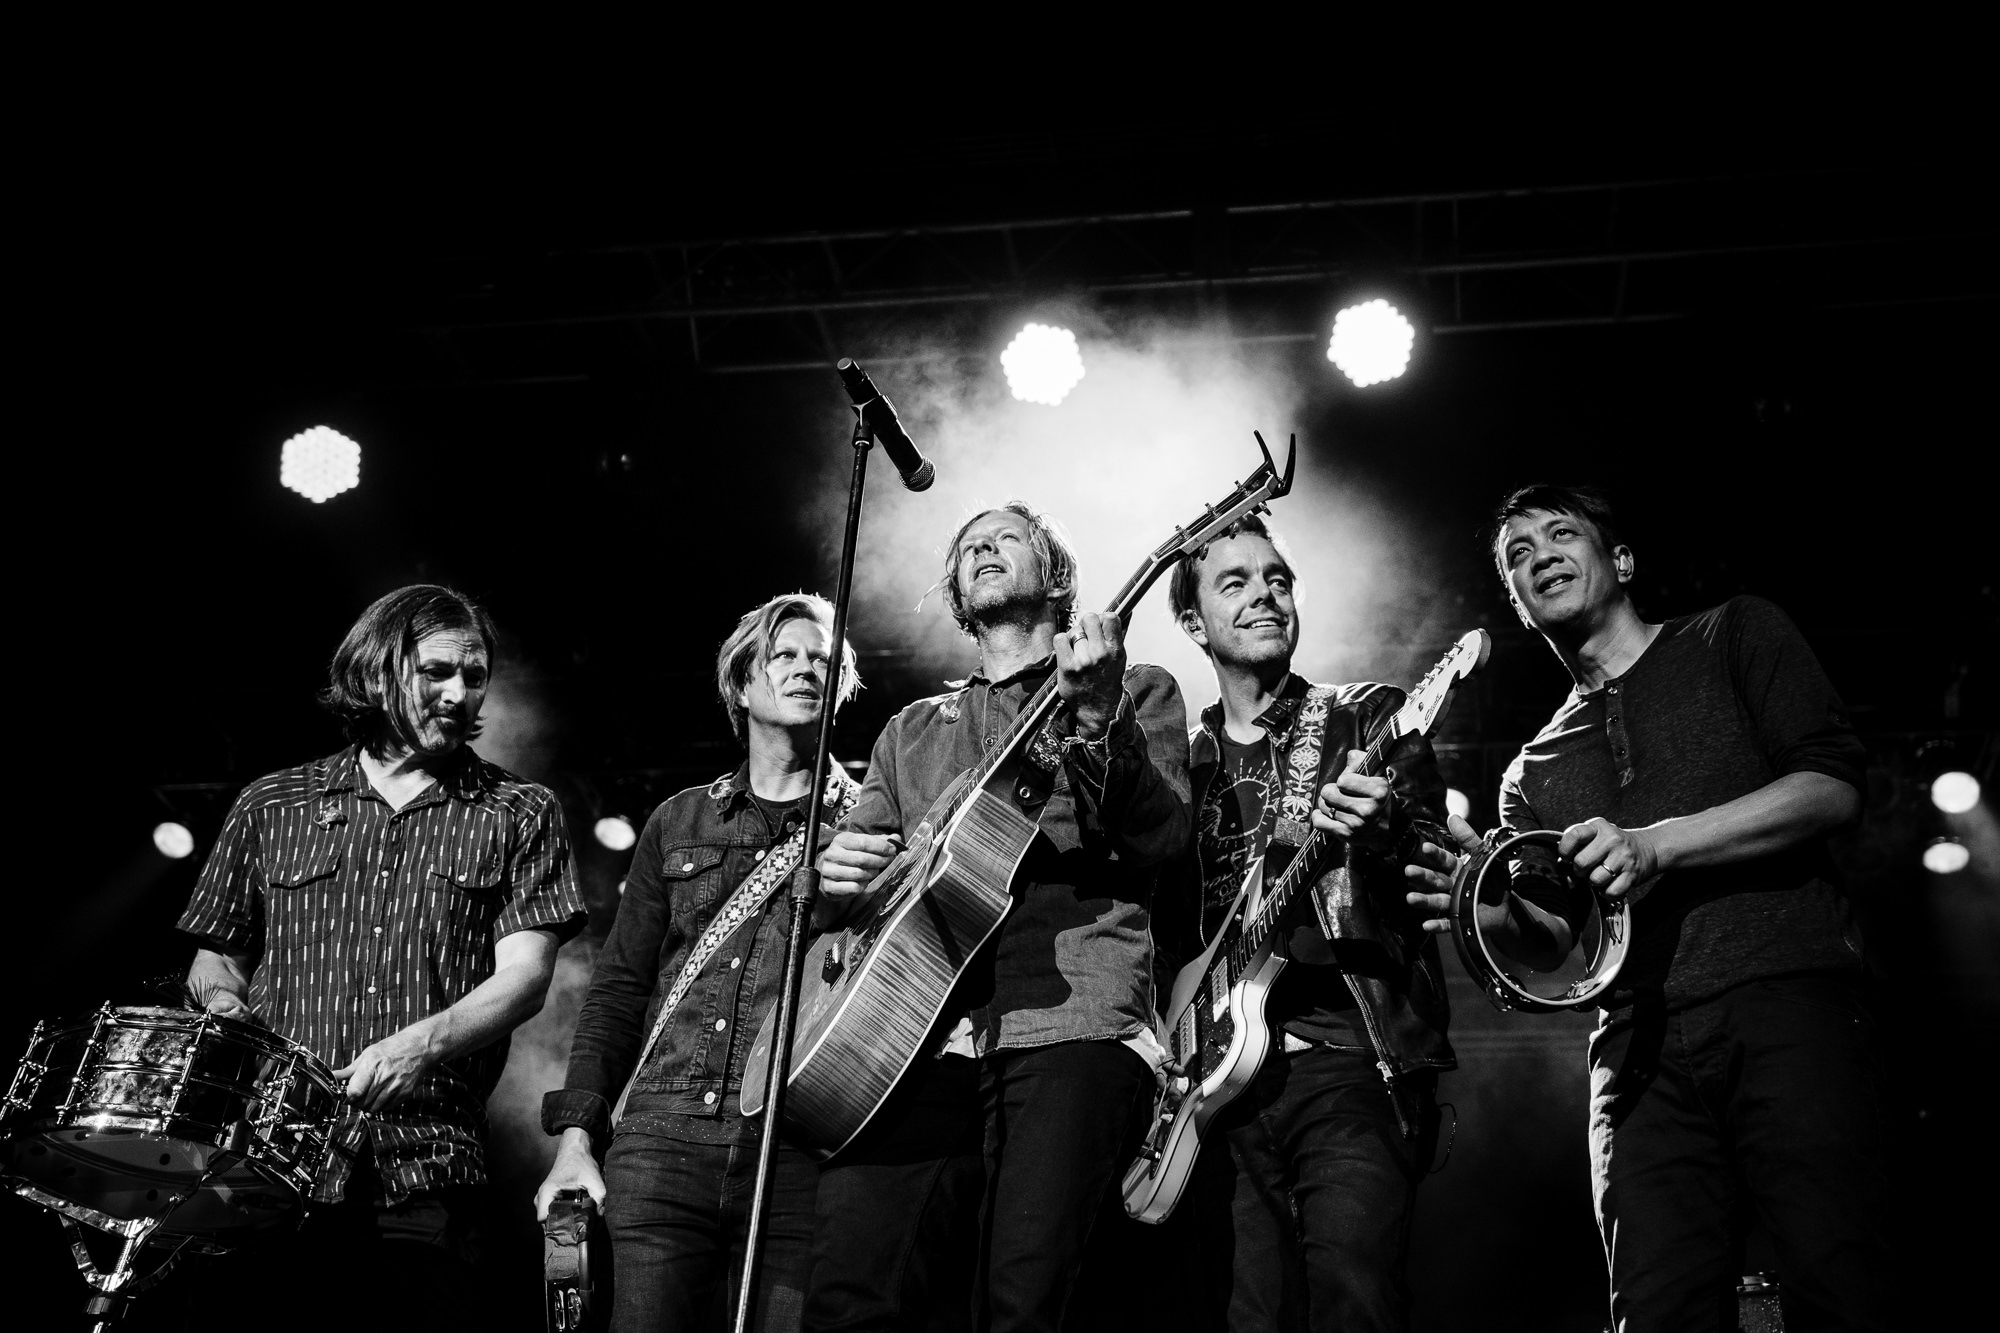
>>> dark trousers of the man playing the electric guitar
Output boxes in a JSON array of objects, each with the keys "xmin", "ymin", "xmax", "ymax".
[{"xmin": 1194, "ymin": 1047, "xmax": 1438, "ymax": 1333}]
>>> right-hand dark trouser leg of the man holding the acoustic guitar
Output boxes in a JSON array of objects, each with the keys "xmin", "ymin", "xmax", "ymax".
[{"xmin": 974, "ymin": 1041, "xmax": 1154, "ymax": 1333}]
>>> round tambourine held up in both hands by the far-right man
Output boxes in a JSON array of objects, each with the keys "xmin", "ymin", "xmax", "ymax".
[{"xmin": 1450, "ymin": 829, "xmax": 1632, "ymax": 1013}]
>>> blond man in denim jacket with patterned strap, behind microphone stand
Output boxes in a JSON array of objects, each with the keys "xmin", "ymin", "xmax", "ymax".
[{"xmin": 536, "ymin": 592, "xmax": 860, "ymax": 1333}]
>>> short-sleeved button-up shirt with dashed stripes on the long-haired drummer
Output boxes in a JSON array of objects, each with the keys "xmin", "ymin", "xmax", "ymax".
[{"xmin": 180, "ymin": 747, "xmax": 584, "ymax": 1203}]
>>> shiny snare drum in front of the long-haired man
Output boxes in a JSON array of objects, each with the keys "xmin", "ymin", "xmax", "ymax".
[{"xmin": 0, "ymin": 1005, "xmax": 342, "ymax": 1249}]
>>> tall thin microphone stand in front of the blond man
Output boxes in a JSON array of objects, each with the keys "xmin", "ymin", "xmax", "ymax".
[{"xmin": 736, "ymin": 406, "xmax": 874, "ymax": 1333}]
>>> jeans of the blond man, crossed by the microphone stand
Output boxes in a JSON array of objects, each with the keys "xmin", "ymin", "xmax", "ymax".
[{"xmin": 604, "ymin": 1117, "xmax": 820, "ymax": 1333}]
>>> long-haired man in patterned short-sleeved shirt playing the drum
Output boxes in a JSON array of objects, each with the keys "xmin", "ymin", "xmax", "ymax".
[{"xmin": 180, "ymin": 584, "xmax": 584, "ymax": 1327}]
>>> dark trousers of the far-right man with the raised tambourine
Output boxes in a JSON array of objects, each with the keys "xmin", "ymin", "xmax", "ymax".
[{"xmin": 1590, "ymin": 977, "xmax": 1898, "ymax": 1333}]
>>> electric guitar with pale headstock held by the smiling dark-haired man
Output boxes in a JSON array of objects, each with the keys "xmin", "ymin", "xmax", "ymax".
[{"xmin": 1124, "ymin": 630, "xmax": 1492, "ymax": 1223}]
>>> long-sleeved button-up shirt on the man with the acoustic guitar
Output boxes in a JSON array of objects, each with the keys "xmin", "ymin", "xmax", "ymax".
[{"xmin": 842, "ymin": 658, "xmax": 1194, "ymax": 1053}]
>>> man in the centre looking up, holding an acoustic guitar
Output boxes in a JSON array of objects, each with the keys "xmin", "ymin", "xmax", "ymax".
[{"xmin": 808, "ymin": 502, "xmax": 1190, "ymax": 1331}]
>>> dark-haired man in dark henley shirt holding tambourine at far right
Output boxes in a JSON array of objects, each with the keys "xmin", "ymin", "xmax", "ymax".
[{"xmin": 1412, "ymin": 486, "xmax": 1896, "ymax": 1333}]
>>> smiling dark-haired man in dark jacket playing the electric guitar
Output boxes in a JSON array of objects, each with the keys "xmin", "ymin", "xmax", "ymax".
[{"xmin": 1160, "ymin": 516, "xmax": 1454, "ymax": 1333}]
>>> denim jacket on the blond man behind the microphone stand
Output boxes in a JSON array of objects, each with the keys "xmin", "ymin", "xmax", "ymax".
[{"xmin": 542, "ymin": 767, "xmax": 836, "ymax": 1147}]
